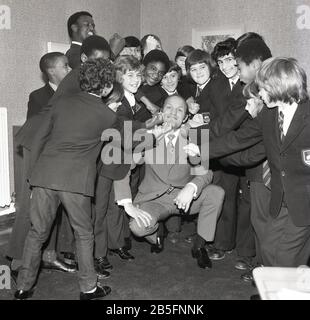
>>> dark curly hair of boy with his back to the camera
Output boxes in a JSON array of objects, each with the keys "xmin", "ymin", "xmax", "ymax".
[{"xmin": 79, "ymin": 58, "xmax": 115, "ymax": 94}]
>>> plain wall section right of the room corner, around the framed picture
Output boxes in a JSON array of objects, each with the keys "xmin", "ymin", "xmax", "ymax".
[{"xmin": 141, "ymin": 0, "xmax": 310, "ymax": 76}]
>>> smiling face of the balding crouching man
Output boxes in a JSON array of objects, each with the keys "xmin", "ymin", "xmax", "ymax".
[{"xmin": 163, "ymin": 96, "xmax": 187, "ymax": 130}]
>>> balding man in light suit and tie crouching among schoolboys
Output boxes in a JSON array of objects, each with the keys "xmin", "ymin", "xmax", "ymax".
[{"xmin": 114, "ymin": 95, "xmax": 224, "ymax": 268}]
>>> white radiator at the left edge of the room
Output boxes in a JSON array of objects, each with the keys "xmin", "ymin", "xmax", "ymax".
[{"xmin": 0, "ymin": 108, "xmax": 11, "ymax": 208}]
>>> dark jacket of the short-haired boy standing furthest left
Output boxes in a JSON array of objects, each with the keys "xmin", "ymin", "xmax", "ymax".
[{"xmin": 27, "ymin": 83, "xmax": 55, "ymax": 119}]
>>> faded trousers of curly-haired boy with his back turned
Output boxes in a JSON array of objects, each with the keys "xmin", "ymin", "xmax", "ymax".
[{"xmin": 17, "ymin": 187, "xmax": 97, "ymax": 292}]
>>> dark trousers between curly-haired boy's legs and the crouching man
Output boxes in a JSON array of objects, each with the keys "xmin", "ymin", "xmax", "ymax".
[{"xmin": 93, "ymin": 175, "xmax": 125, "ymax": 258}]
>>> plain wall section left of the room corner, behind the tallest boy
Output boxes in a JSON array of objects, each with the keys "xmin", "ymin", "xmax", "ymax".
[{"xmin": 0, "ymin": 0, "xmax": 140, "ymax": 195}]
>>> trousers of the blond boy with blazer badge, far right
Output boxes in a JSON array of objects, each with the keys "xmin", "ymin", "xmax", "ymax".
[{"xmin": 261, "ymin": 206, "xmax": 310, "ymax": 268}]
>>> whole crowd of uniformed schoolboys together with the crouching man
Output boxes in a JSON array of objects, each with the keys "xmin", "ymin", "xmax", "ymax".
[{"xmin": 8, "ymin": 11, "xmax": 310, "ymax": 300}]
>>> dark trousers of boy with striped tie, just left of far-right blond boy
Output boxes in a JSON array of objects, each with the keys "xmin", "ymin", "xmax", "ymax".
[{"xmin": 250, "ymin": 182, "xmax": 271, "ymax": 264}]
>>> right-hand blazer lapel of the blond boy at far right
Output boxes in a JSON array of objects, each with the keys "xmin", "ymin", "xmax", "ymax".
[{"xmin": 278, "ymin": 102, "xmax": 309, "ymax": 151}]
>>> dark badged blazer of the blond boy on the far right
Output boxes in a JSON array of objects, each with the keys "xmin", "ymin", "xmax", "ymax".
[{"xmin": 203, "ymin": 100, "xmax": 310, "ymax": 226}]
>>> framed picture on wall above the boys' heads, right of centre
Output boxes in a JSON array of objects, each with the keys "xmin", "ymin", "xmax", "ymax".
[{"xmin": 192, "ymin": 26, "xmax": 244, "ymax": 53}]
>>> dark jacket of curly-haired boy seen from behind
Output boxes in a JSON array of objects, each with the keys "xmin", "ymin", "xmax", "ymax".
[{"xmin": 30, "ymin": 92, "xmax": 118, "ymax": 196}]
